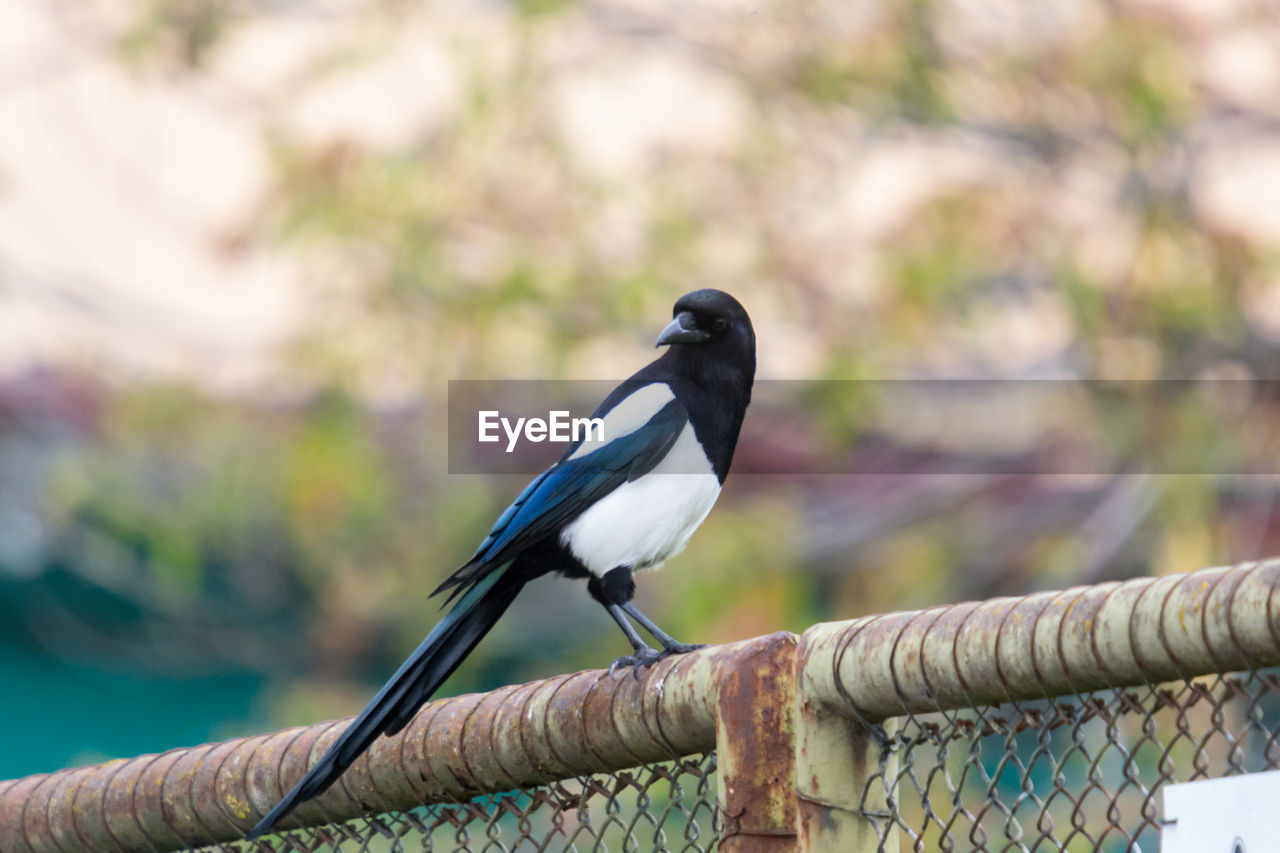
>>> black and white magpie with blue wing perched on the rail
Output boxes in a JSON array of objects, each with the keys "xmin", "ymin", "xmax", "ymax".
[{"xmin": 246, "ymin": 288, "xmax": 755, "ymax": 840}]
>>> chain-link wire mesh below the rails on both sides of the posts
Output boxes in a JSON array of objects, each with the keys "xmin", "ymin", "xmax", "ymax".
[{"xmin": 186, "ymin": 670, "xmax": 1280, "ymax": 853}]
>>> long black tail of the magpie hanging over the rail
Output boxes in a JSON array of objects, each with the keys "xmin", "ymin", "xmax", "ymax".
[{"xmin": 244, "ymin": 566, "xmax": 524, "ymax": 840}]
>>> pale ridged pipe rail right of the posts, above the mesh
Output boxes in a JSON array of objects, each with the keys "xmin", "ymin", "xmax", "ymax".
[{"xmin": 799, "ymin": 560, "xmax": 1280, "ymax": 719}]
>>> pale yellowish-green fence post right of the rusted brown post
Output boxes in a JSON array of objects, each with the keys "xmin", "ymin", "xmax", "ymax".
[{"xmin": 795, "ymin": 622, "xmax": 897, "ymax": 853}]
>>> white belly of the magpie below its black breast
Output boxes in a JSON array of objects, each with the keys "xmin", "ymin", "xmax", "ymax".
[{"xmin": 561, "ymin": 425, "xmax": 721, "ymax": 576}]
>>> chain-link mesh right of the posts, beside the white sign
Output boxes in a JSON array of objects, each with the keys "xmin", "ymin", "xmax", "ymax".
[{"xmin": 856, "ymin": 670, "xmax": 1280, "ymax": 853}]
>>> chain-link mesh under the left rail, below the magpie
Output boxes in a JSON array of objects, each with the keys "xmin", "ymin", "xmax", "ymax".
[{"xmin": 201, "ymin": 753, "xmax": 719, "ymax": 853}]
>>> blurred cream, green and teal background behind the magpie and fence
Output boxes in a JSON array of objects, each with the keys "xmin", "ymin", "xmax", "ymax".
[{"xmin": 0, "ymin": 0, "xmax": 1280, "ymax": 777}]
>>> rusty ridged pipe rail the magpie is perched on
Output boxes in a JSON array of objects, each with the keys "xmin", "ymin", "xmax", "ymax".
[{"xmin": 0, "ymin": 634, "xmax": 795, "ymax": 853}]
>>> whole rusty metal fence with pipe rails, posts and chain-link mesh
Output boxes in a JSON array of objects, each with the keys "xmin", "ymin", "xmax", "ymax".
[{"xmin": 0, "ymin": 562, "xmax": 1280, "ymax": 853}]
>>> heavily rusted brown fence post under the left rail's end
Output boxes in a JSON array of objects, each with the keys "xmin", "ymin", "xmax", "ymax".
[{"xmin": 716, "ymin": 631, "xmax": 799, "ymax": 853}]
